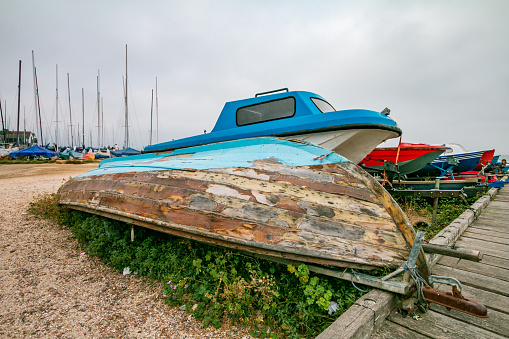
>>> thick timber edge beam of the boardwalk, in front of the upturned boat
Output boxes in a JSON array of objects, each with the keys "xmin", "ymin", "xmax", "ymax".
[{"xmin": 316, "ymin": 290, "xmax": 398, "ymax": 339}]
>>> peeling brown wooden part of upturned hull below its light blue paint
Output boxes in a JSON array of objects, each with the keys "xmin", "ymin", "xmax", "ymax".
[{"xmin": 61, "ymin": 163, "xmax": 424, "ymax": 267}]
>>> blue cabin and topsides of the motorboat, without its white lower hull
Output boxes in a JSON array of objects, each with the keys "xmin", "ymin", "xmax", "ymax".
[{"xmin": 144, "ymin": 91, "xmax": 401, "ymax": 153}]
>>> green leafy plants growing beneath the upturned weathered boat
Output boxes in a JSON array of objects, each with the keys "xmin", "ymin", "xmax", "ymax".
[{"xmin": 29, "ymin": 194, "xmax": 363, "ymax": 338}]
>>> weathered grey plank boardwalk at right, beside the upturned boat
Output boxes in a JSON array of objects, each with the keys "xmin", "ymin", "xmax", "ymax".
[{"xmin": 372, "ymin": 185, "xmax": 509, "ymax": 338}]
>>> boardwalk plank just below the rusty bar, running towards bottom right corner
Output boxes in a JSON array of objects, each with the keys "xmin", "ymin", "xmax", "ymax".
[{"xmin": 387, "ymin": 310, "xmax": 504, "ymax": 338}]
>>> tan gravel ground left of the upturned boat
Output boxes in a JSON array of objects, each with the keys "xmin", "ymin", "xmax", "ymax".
[{"xmin": 0, "ymin": 164, "xmax": 250, "ymax": 338}]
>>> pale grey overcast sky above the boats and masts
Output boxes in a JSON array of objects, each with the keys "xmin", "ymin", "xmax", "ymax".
[{"xmin": 0, "ymin": 0, "xmax": 509, "ymax": 154}]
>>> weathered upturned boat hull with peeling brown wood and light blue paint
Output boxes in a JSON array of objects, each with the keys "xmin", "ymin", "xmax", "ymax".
[{"xmin": 59, "ymin": 138, "xmax": 426, "ymax": 269}]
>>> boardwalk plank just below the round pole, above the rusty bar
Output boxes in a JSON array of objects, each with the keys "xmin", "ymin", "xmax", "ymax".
[{"xmin": 433, "ymin": 264, "xmax": 509, "ymax": 297}]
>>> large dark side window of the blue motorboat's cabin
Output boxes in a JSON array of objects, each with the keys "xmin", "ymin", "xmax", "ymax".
[{"xmin": 237, "ymin": 97, "xmax": 295, "ymax": 126}]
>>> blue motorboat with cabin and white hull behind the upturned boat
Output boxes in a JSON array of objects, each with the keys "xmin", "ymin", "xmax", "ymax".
[{"xmin": 143, "ymin": 88, "xmax": 401, "ymax": 163}]
